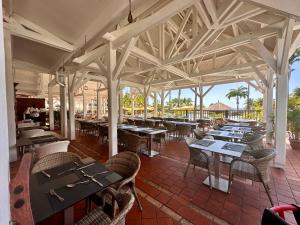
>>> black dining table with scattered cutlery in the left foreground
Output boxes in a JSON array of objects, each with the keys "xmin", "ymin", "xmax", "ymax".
[{"xmin": 30, "ymin": 158, "xmax": 122, "ymax": 225}]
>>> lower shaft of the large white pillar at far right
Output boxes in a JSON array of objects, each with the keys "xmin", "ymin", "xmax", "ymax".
[{"xmin": 275, "ymin": 75, "xmax": 288, "ymax": 168}]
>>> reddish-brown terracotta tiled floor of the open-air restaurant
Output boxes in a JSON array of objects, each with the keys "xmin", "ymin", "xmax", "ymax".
[{"xmin": 10, "ymin": 136, "xmax": 300, "ymax": 225}]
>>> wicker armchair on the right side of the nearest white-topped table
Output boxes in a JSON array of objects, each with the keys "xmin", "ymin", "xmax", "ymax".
[{"xmin": 228, "ymin": 149, "xmax": 275, "ymax": 206}]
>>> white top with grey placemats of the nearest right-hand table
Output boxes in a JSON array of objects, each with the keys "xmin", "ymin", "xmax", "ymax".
[{"xmin": 190, "ymin": 139, "xmax": 247, "ymax": 157}]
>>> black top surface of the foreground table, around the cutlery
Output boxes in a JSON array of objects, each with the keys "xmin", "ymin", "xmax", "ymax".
[{"xmin": 30, "ymin": 162, "xmax": 122, "ymax": 223}]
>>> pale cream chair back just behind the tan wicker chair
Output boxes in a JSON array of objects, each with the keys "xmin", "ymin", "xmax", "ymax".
[{"xmin": 35, "ymin": 141, "xmax": 70, "ymax": 160}]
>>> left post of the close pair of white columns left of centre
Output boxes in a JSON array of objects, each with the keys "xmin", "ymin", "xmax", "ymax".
[{"xmin": 59, "ymin": 75, "xmax": 68, "ymax": 137}]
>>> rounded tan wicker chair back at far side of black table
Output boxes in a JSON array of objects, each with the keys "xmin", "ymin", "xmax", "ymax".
[{"xmin": 31, "ymin": 152, "xmax": 80, "ymax": 174}]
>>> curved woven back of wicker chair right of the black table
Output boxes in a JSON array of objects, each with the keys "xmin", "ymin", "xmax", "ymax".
[{"xmin": 105, "ymin": 151, "xmax": 141, "ymax": 181}]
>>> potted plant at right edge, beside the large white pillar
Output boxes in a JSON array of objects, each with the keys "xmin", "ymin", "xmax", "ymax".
[{"xmin": 288, "ymin": 109, "xmax": 300, "ymax": 150}]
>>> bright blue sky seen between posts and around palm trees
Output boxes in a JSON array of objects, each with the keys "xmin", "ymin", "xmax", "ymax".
[{"xmin": 125, "ymin": 62, "xmax": 300, "ymax": 108}]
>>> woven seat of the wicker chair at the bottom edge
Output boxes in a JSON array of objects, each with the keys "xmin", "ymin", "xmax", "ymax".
[{"xmin": 76, "ymin": 207, "xmax": 111, "ymax": 225}]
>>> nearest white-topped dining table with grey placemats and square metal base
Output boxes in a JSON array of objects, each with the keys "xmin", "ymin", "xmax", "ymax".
[{"xmin": 189, "ymin": 139, "xmax": 247, "ymax": 193}]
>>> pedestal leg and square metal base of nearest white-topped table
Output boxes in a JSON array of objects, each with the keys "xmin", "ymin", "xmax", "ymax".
[{"xmin": 203, "ymin": 153, "xmax": 228, "ymax": 192}]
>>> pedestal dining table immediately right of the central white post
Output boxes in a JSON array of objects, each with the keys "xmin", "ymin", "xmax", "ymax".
[{"xmin": 118, "ymin": 124, "xmax": 167, "ymax": 157}]
